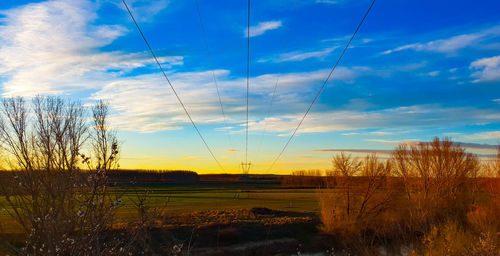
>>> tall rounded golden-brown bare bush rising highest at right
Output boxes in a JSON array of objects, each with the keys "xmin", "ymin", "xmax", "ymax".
[{"xmin": 393, "ymin": 138, "xmax": 480, "ymax": 227}]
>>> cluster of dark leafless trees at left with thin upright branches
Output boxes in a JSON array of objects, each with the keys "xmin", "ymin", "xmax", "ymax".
[{"xmin": 0, "ymin": 96, "xmax": 125, "ymax": 255}]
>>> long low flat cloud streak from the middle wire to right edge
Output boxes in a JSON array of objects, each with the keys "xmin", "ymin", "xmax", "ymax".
[{"xmin": 246, "ymin": 105, "xmax": 498, "ymax": 135}]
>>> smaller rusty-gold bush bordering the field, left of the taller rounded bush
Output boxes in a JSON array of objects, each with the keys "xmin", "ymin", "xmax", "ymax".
[{"xmin": 319, "ymin": 153, "xmax": 392, "ymax": 238}]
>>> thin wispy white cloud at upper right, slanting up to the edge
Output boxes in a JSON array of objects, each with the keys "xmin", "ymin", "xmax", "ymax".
[{"xmin": 383, "ymin": 26, "xmax": 500, "ymax": 54}]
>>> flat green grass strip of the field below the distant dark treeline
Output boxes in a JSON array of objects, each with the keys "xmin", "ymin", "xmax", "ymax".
[{"xmin": 0, "ymin": 184, "xmax": 319, "ymax": 233}]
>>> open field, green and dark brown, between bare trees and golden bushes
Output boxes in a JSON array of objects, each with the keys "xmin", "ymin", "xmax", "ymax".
[{"xmin": 0, "ymin": 181, "xmax": 326, "ymax": 254}]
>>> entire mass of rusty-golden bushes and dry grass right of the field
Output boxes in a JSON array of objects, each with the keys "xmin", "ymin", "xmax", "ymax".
[{"xmin": 318, "ymin": 139, "xmax": 500, "ymax": 255}]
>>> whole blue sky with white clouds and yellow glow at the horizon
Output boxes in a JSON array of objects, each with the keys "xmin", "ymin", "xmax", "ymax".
[{"xmin": 0, "ymin": 0, "xmax": 500, "ymax": 174}]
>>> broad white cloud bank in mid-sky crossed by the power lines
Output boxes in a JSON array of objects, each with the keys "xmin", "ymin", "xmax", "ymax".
[{"xmin": 92, "ymin": 69, "xmax": 364, "ymax": 133}]
